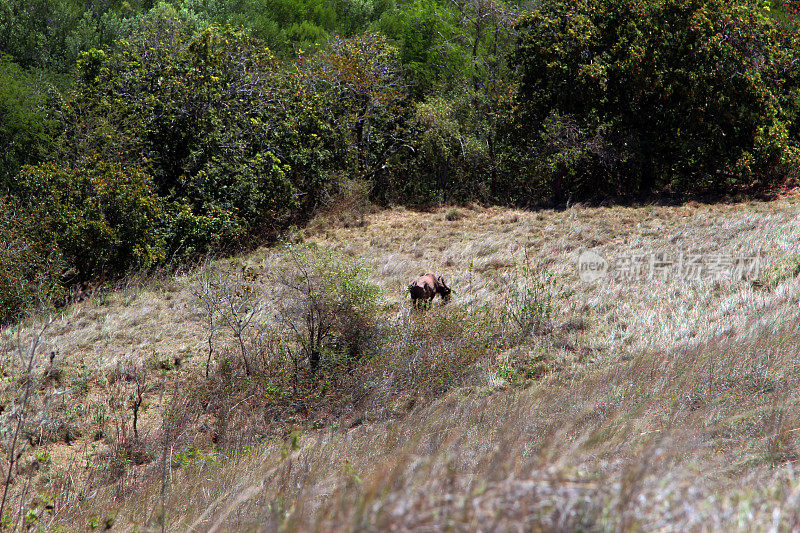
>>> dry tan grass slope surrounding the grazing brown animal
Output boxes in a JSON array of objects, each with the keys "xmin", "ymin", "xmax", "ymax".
[{"xmin": 0, "ymin": 198, "xmax": 800, "ymax": 531}]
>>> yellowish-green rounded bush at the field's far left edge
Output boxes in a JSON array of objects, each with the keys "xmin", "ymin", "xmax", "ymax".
[{"xmin": 12, "ymin": 158, "xmax": 163, "ymax": 279}]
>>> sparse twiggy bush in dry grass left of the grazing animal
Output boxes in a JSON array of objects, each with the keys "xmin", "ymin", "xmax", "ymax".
[{"xmin": 195, "ymin": 245, "xmax": 382, "ymax": 432}]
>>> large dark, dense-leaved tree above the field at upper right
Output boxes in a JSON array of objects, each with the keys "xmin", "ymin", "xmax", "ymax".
[{"xmin": 512, "ymin": 0, "xmax": 795, "ymax": 200}]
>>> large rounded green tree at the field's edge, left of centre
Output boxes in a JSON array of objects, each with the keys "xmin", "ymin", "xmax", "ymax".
[{"xmin": 67, "ymin": 21, "xmax": 314, "ymax": 256}]
